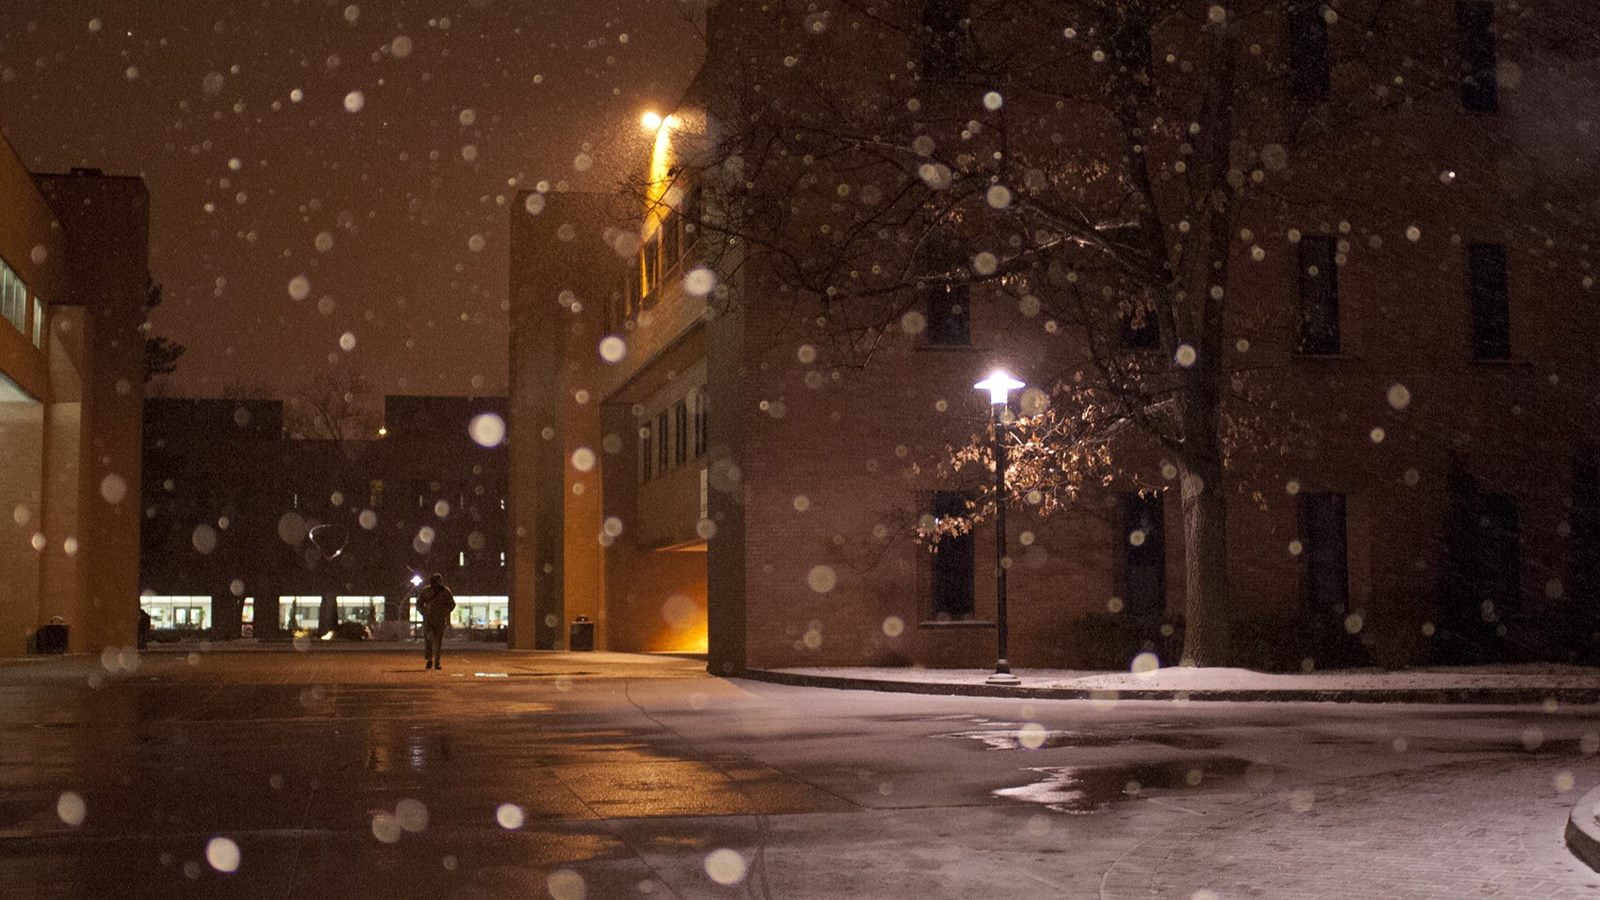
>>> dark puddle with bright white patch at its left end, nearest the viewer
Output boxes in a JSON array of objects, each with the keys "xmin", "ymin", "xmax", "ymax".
[{"xmin": 994, "ymin": 756, "xmax": 1272, "ymax": 815}]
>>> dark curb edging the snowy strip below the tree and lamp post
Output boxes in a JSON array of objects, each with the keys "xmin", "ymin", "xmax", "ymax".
[{"xmin": 739, "ymin": 669, "xmax": 1600, "ymax": 701}]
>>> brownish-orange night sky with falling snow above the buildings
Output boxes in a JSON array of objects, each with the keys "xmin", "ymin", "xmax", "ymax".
[{"xmin": 0, "ymin": 0, "xmax": 702, "ymax": 397}]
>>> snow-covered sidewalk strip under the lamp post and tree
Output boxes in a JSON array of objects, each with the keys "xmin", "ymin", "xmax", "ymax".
[{"xmin": 744, "ymin": 663, "xmax": 1600, "ymax": 705}]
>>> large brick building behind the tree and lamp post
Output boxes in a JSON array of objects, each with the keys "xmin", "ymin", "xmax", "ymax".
[{"xmin": 510, "ymin": 0, "xmax": 1600, "ymax": 674}]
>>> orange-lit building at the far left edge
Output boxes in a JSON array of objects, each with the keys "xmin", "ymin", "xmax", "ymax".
[{"xmin": 0, "ymin": 141, "xmax": 149, "ymax": 655}]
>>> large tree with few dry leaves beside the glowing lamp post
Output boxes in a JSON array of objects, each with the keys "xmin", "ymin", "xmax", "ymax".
[{"xmin": 672, "ymin": 0, "xmax": 1523, "ymax": 665}]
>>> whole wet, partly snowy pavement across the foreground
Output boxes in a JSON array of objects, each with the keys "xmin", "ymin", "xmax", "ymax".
[{"xmin": 0, "ymin": 645, "xmax": 1600, "ymax": 900}]
